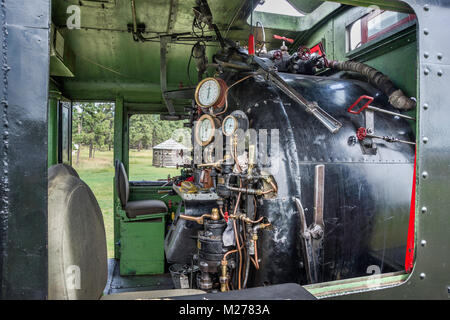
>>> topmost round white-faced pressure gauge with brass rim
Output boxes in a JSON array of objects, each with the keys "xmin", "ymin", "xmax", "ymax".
[{"xmin": 195, "ymin": 78, "xmax": 227, "ymax": 108}]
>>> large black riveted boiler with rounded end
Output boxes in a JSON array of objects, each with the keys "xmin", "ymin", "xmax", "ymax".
[{"xmin": 225, "ymin": 74, "xmax": 415, "ymax": 286}]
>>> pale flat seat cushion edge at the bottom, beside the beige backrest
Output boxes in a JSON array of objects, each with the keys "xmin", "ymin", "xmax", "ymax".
[{"xmin": 101, "ymin": 289, "xmax": 205, "ymax": 300}]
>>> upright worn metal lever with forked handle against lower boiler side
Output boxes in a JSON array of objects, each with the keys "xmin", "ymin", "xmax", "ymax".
[{"xmin": 294, "ymin": 165, "xmax": 325, "ymax": 283}]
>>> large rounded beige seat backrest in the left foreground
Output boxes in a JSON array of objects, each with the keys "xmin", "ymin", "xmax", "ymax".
[{"xmin": 48, "ymin": 165, "xmax": 108, "ymax": 300}]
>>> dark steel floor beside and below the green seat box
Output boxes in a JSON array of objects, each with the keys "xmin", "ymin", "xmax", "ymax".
[{"xmin": 103, "ymin": 259, "xmax": 175, "ymax": 295}]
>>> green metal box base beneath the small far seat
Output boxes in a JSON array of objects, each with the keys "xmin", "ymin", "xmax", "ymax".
[{"xmin": 120, "ymin": 215, "xmax": 165, "ymax": 275}]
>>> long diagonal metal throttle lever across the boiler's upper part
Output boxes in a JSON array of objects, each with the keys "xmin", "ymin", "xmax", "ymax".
[{"xmin": 252, "ymin": 56, "xmax": 342, "ymax": 133}]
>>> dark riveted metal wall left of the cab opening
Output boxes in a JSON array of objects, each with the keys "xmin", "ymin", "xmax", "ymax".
[{"xmin": 0, "ymin": 0, "xmax": 50, "ymax": 299}]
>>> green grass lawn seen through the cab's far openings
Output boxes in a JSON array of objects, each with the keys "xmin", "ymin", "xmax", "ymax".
[{"xmin": 72, "ymin": 146, "xmax": 180, "ymax": 258}]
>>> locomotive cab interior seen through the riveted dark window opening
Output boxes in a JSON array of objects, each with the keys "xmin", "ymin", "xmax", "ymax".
[{"xmin": 48, "ymin": 0, "xmax": 419, "ymax": 299}]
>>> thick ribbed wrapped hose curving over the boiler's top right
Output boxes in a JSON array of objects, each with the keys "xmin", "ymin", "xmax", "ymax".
[{"xmin": 329, "ymin": 61, "xmax": 416, "ymax": 110}]
